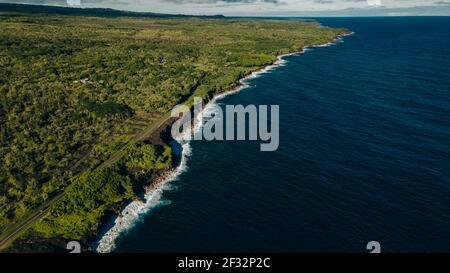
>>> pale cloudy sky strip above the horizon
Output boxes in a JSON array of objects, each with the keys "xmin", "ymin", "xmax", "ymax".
[{"xmin": 0, "ymin": 0, "xmax": 450, "ymax": 16}]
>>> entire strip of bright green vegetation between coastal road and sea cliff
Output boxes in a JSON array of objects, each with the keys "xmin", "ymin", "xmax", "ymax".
[{"xmin": 33, "ymin": 142, "xmax": 172, "ymax": 239}]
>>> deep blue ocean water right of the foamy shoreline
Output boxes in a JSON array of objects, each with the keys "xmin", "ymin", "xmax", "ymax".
[{"xmin": 115, "ymin": 17, "xmax": 450, "ymax": 252}]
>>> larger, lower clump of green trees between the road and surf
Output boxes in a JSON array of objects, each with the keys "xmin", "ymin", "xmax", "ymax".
[{"xmin": 34, "ymin": 164, "xmax": 133, "ymax": 239}]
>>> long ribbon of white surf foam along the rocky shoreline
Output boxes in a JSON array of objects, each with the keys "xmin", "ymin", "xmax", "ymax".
[{"xmin": 95, "ymin": 33, "xmax": 353, "ymax": 253}]
